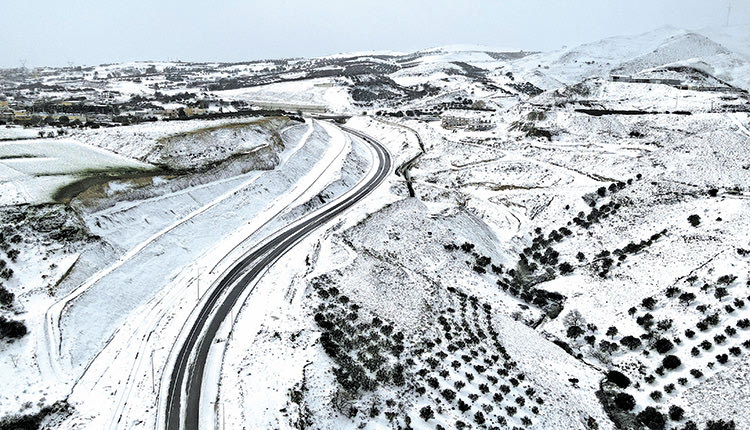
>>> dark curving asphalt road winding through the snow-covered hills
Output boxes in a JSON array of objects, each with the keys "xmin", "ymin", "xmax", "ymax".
[{"xmin": 164, "ymin": 122, "xmax": 392, "ymax": 430}]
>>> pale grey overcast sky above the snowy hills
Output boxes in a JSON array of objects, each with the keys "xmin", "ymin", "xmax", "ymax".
[{"xmin": 0, "ymin": 0, "xmax": 750, "ymax": 67}]
